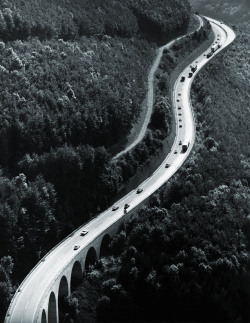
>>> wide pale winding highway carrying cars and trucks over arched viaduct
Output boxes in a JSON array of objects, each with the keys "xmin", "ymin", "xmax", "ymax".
[{"xmin": 5, "ymin": 17, "xmax": 235, "ymax": 323}]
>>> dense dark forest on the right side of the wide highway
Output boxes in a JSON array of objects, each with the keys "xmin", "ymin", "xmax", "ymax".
[{"xmin": 62, "ymin": 5, "xmax": 250, "ymax": 322}]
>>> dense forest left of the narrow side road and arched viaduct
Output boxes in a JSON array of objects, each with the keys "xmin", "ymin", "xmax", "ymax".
[{"xmin": 0, "ymin": 0, "xmax": 191, "ymax": 321}]
